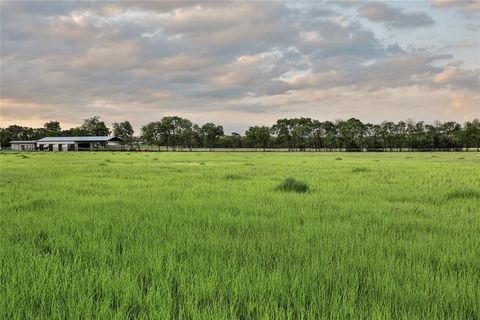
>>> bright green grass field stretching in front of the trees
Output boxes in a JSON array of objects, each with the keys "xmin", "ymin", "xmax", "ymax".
[{"xmin": 0, "ymin": 152, "xmax": 480, "ymax": 319}]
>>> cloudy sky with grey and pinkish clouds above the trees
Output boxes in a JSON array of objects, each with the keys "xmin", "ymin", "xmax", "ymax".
[{"xmin": 0, "ymin": 0, "xmax": 480, "ymax": 132}]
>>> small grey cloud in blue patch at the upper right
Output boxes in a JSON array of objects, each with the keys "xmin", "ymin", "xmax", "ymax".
[{"xmin": 359, "ymin": 2, "xmax": 435, "ymax": 28}]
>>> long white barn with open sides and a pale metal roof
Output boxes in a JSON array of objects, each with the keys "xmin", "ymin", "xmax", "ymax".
[{"xmin": 37, "ymin": 136, "xmax": 123, "ymax": 151}]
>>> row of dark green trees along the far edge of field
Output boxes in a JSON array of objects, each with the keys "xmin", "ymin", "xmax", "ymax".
[{"xmin": 0, "ymin": 116, "xmax": 480, "ymax": 150}]
